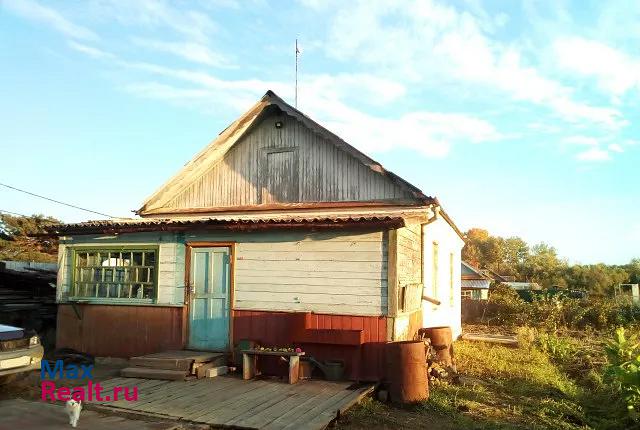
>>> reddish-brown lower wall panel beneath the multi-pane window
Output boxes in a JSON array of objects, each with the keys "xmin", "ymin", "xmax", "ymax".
[{"xmin": 56, "ymin": 304, "xmax": 186, "ymax": 357}]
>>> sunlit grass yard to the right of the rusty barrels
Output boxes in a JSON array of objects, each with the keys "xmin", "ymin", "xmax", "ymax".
[{"xmin": 337, "ymin": 330, "xmax": 640, "ymax": 430}]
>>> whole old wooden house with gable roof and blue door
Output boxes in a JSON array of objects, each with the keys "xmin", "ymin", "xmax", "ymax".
[{"xmin": 46, "ymin": 91, "xmax": 463, "ymax": 380}]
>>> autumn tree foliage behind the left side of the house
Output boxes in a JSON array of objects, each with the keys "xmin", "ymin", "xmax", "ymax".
[{"xmin": 0, "ymin": 214, "xmax": 60, "ymax": 262}]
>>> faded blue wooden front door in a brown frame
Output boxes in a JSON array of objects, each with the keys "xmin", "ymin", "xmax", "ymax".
[{"xmin": 189, "ymin": 247, "xmax": 231, "ymax": 351}]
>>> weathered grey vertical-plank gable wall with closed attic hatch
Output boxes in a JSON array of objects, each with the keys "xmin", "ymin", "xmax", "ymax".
[{"xmin": 165, "ymin": 115, "xmax": 412, "ymax": 210}]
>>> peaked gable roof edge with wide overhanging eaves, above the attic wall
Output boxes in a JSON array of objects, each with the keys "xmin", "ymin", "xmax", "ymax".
[{"xmin": 136, "ymin": 90, "xmax": 435, "ymax": 216}]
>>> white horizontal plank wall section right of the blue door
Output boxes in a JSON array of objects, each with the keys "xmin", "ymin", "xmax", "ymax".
[{"xmin": 185, "ymin": 231, "xmax": 388, "ymax": 315}]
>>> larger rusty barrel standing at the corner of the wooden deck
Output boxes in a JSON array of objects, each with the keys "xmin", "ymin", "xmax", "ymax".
[{"xmin": 385, "ymin": 340, "xmax": 429, "ymax": 403}]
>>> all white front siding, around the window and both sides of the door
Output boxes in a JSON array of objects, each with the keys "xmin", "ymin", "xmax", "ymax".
[{"xmin": 59, "ymin": 231, "xmax": 388, "ymax": 315}]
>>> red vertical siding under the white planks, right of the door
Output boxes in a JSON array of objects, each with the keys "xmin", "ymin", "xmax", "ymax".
[{"xmin": 233, "ymin": 310, "xmax": 387, "ymax": 381}]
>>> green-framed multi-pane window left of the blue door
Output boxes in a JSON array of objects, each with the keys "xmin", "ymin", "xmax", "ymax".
[{"xmin": 70, "ymin": 248, "xmax": 158, "ymax": 302}]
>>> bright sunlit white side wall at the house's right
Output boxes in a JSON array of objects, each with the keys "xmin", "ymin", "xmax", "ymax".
[{"xmin": 422, "ymin": 216, "xmax": 464, "ymax": 338}]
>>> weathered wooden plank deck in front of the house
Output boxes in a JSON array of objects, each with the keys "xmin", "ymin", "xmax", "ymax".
[{"xmin": 89, "ymin": 376, "xmax": 373, "ymax": 430}]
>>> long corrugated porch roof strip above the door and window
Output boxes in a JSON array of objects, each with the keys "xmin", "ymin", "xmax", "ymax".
[{"xmin": 47, "ymin": 215, "xmax": 404, "ymax": 234}]
